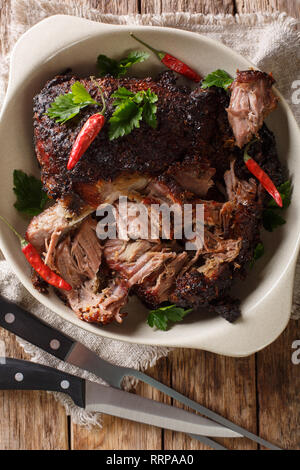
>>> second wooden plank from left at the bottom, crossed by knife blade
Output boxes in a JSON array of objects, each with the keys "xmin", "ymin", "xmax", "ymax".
[{"xmin": 71, "ymin": 358, "xmax": 170, "ymax": 450}]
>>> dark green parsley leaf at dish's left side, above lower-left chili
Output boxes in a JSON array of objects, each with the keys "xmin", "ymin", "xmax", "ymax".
[{"xmin": 13, "ymin": 170, "xmax": 48, "ymax": 216}]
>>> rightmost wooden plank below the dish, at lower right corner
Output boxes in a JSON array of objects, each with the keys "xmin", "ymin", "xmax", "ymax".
[{"xmin": 257, "ymin": 320, "xmax": 300, "ymax": 450}]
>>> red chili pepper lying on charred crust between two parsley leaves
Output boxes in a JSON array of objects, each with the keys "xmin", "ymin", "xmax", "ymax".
[{"xmin": 67, "ymin": 81, "xmax": 106, "ymax": 170}]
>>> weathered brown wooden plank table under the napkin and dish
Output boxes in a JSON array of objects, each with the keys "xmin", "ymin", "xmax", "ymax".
[{"xmin": 0, "ymin": 0, "xmax": 300, "ymax": 450}]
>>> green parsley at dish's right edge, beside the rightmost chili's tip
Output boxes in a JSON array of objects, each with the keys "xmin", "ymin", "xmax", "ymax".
[{"xmin": 263, "ymin": 181, "xmax": 292, "ymax": 232}]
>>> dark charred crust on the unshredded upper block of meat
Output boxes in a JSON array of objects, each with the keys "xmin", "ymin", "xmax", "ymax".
[{"xmin": 34, "ymin": 74, "xmax": 232, "ymax": 198}]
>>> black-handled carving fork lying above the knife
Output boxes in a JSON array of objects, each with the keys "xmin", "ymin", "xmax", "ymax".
[{"xmin": 0, "ymin": 297, "xmax": 280, "ymax": 450}]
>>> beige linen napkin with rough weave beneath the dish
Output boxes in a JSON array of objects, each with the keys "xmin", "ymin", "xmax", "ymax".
[{"xmin": 0, "ymin": 0, "xmax": 300, "ymax": 425}]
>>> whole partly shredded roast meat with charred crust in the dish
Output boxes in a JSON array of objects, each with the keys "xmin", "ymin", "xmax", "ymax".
[{"xmin": 22, "ymin": 63, "xmax": 285, "ymax": 325}]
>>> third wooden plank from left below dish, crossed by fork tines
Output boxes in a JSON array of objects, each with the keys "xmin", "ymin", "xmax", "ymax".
[{"xmin": 164, "ymin": 349, "xmax": 257, "ymax": 450}]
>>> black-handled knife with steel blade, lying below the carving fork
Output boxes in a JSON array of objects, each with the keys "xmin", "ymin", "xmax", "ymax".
[{"xmin": 0, "ymin": 358, "xmax": 235, "ymax": 437}]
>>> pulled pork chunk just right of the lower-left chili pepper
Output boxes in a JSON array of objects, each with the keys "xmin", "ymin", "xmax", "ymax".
[{"xmin": 55, "ymin": 217, "xmax": 128, "ymax": 324}]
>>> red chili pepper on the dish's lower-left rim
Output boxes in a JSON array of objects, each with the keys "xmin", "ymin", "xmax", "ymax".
[{"xmin": 0, "ymin": 215, "xmax": 72, "ymax": 291}]
